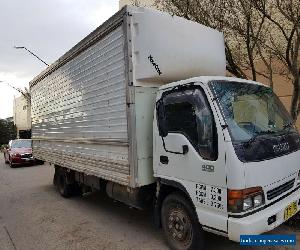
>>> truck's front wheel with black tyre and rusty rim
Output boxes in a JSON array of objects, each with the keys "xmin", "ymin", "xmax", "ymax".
[{"xmin": 161, "ymin": 193, "xmax": 204, "ymax": 250}]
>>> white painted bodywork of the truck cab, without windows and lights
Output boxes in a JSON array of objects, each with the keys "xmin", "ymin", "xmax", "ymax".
[{"xmin": 153, "ymin": 76, "xmax": 300, "ymax": 241}]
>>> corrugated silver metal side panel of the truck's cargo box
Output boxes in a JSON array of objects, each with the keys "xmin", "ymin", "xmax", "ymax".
[{"xmin": 31, "ymin": 26, "xmax": 130, "ymax": 185}]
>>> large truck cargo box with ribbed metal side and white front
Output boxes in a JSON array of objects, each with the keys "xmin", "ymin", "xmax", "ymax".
[{"xmin": 30, "ymin": 6, "xmax": 225, "ymax": 187}]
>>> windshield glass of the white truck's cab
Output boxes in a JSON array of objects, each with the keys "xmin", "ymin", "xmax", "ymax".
[{"xmin": 210, "ymin": 81, "xmax": 296, "ymax": 141}]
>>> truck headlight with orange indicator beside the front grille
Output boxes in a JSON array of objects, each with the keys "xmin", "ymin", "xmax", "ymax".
[{"xmin": 227, "ymin": 187, "xmax": 264, "ymax": 213}]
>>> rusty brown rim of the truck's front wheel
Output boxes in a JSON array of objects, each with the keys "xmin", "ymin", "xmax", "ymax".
[{"xmin": 167, "ymin": 208, "xmax": 193, "ymax": 247}]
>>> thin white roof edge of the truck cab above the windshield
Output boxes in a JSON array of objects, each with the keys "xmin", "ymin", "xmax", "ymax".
[{"xmin": 159, "ymin": 76, "xmax": 268, "ymax": 90}]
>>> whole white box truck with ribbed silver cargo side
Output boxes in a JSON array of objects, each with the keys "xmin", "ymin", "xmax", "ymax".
[{"xmin": 30, "ymin": 6, "xmax": 300, "ymax": 249}]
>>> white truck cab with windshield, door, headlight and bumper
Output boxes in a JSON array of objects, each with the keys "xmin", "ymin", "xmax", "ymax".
[{"xmin": 153, "ymin": 77, "xmax": 300, "ymax": 245}]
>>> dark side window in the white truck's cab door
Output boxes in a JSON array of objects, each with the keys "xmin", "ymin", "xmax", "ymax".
[{"xmin": 164, "ymin": 88, "xmax": 218, "ymax": 160}]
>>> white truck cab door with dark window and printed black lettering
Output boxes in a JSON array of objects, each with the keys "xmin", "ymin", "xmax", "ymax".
[{"xmin": 154, "ymin": 85, "xmax": 227, "ymax": 232}]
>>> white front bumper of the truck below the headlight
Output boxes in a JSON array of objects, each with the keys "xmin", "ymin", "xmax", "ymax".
[{"xmin": 228, "ymin": 189, "xmax": 300, "ymax": 242}]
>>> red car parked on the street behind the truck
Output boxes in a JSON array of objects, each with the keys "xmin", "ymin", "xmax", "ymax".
[{"xmin": 4, "ymin": 139, "xmax": 35, "ymax": 168}]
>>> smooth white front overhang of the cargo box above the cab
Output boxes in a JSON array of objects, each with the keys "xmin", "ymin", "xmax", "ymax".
[{"xmin": 131, "ymin": 7, "xmax": 226, "ymax": 85}]
